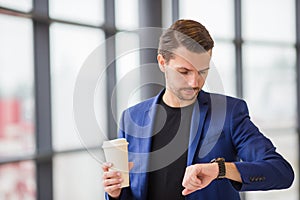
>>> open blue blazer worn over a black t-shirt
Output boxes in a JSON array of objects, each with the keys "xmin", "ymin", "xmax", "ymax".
[{"xmin": 106, "ymin": 91, "xmax": 294, "ymax": 200}]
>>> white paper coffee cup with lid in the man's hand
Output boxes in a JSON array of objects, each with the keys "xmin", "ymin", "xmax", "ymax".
[{"xmin": 102, "ymin": 138, "xmax": 129, "ymax": 188}]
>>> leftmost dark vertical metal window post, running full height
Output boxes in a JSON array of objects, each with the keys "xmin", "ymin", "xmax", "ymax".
[{"xmin": 33, "ymin": 0, "xmax": 53, "ymax": 200}]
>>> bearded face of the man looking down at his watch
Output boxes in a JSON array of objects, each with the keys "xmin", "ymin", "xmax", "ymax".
[{"xmin": 158, "ymin": 47, "xmax": 211, "ymax": 106}]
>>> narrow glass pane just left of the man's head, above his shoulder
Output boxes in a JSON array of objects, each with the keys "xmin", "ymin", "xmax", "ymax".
[{"xmin": 116, "ymin": 32, "xmax": 140, "ymax": 122}]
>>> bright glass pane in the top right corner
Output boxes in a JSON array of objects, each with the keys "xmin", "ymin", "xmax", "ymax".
[{"xmin": 242, "ymin": 0, "xmax": 296, "ymax": 42}]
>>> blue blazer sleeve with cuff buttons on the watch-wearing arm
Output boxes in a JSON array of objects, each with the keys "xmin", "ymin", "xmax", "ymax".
[{"xmin": 230, "ymin": 100, "xmax": 294, "ymax": 191}]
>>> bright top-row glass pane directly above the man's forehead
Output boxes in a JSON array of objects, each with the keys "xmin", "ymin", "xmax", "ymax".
[{"xmin": 179, "ymin": 0, "xmax": 234, "ymax": 39}]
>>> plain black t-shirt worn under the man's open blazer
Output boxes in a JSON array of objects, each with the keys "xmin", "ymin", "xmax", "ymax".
[{"xmin": 147, "ymin": 100, "xmax": 193, "ymax": 200}]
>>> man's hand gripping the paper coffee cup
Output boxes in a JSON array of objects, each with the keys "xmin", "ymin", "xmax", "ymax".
[{"xmin": 102, "ymin": 163, "xmax": 123, "ymax": 199}]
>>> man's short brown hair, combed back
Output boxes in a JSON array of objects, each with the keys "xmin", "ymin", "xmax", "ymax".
[{"xmin": 158, "ymin": 19, "xmax": 214, "ymax": 62}]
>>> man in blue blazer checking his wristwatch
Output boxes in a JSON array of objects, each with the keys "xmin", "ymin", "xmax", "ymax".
[{"xmin": 102, "ymin": 20, "xmax": 294, "ymax": 200}]
